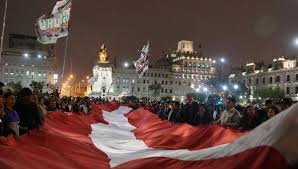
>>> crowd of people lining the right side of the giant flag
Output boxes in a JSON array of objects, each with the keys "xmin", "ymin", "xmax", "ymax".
[{"xmin": 140, "ymin": 96, "xmax": 292, "ymax": 130}]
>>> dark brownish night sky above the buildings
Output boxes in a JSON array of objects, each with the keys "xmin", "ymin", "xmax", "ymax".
[{"xmin": 0, "ymin": 0, "xmax": 298, "ymax": 79}]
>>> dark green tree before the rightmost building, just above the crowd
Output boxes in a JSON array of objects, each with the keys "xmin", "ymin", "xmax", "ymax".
[{"xmin": 255, "ymin": 87, "xmax": 285, "ymax": 101}]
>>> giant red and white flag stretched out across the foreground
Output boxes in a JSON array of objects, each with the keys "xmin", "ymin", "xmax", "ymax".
[{"xmin": 0, "ymin": 102, "xmax": 298, "ymax": 169}]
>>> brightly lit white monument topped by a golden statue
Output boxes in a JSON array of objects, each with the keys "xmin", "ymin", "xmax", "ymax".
[{"xmin": 89, "ymin": 44, "xmax": 114, "ymax": 97}]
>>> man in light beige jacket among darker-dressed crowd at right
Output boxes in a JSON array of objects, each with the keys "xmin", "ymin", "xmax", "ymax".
[{"xmin": 214, "ymin": 97, "xmax": 242, "ymax": 128}]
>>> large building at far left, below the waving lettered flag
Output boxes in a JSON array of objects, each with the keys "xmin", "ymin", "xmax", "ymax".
[{"xmin": 0, "ymin": 34, "xmax": 58, "ymax": 88}]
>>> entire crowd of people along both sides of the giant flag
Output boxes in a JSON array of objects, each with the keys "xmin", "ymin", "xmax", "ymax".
[{"xmin": 0, "ymin": 84, "xmax": 292, "ymax": 137}]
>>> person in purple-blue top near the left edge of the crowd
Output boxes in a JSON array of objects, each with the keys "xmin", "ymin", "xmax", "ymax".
[{"xmin": 3, "ymin": 91, "xmax": 20, "ymax": 137}]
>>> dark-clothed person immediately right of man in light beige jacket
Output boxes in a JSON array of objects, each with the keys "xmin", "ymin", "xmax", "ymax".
[{"xmin": 241, "ymin": 105, "xmax": 261, "ymax": 130}]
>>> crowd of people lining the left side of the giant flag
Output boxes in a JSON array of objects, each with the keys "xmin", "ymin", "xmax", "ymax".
[{"xmin": 0, "ymin": 88, "xmax": 98, "ymax": 138}]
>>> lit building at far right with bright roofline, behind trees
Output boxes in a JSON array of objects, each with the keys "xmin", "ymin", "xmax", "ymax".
[{"xmin": 229, "ymin": 57, "xmax": 298, "ymax": 101}]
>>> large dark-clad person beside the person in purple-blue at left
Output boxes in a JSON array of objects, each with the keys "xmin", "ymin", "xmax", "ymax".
[{"xmin": 15, "ymin": 88, "xmax": 43, "ymax": 134}]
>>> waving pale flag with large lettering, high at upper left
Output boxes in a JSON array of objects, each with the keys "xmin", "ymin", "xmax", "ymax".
[{"xmin": 35, "ymin": 0, "xmax": 72, "ymax": 44}]
